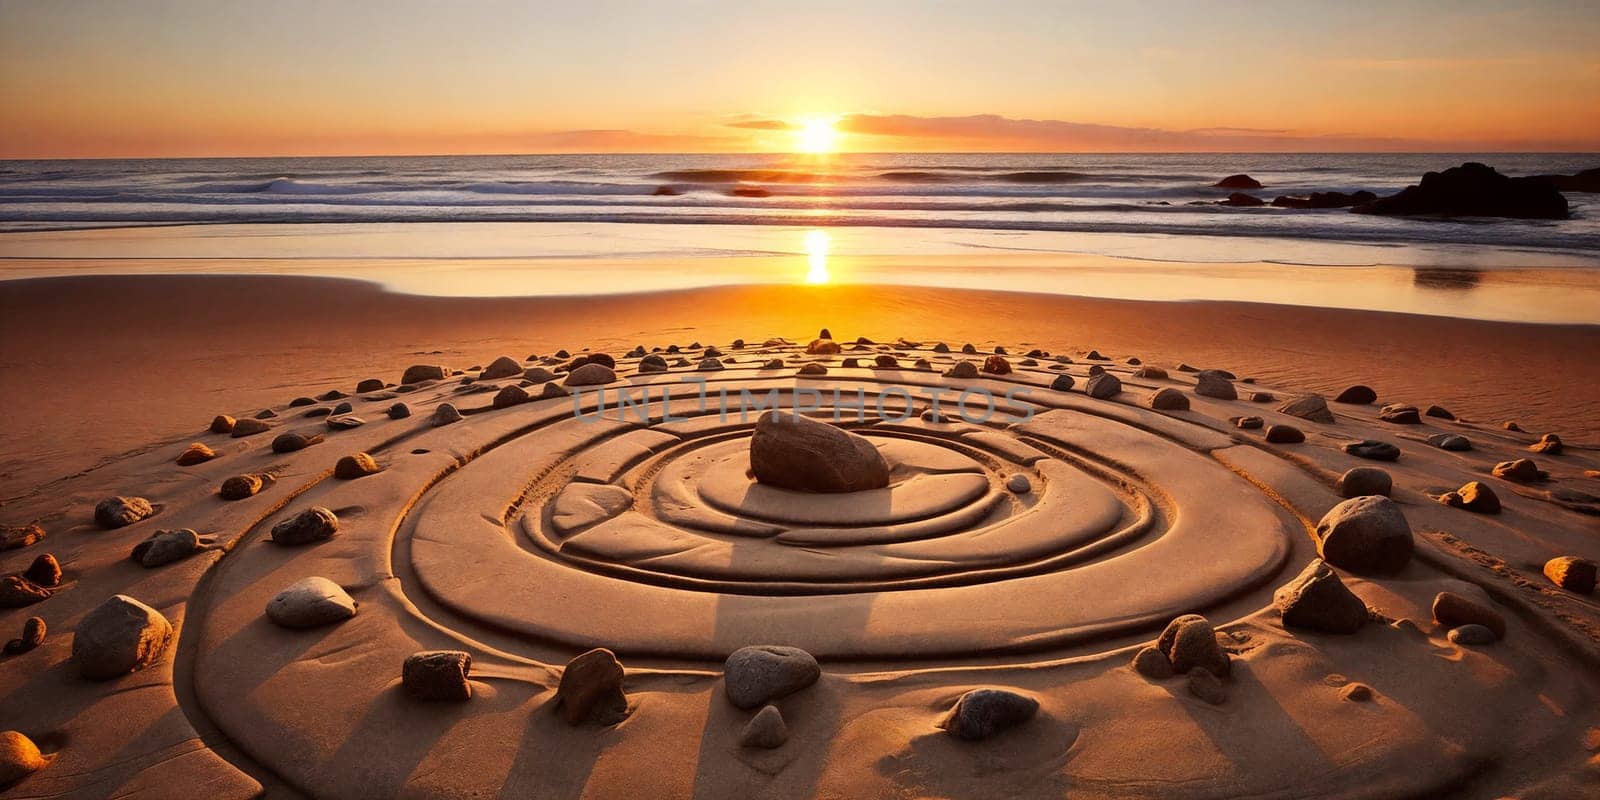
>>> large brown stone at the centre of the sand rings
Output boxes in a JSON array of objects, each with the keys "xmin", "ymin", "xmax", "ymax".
[{"xmin": 750, "ymin": 411, "xmax": 890, "ymax": 493}]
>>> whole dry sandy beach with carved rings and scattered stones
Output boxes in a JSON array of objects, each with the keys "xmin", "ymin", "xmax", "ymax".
[{"xmin": 0, "ymin": 267, "xmax": 1600, "ymax": 798}]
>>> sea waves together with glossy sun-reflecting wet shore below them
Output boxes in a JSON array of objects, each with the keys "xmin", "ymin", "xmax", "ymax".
[{"xmin": 0, "ymin": 154, "xmax": 1600, "ymax": 323}]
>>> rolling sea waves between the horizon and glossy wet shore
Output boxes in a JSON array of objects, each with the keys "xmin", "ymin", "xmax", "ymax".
[{"xmin": 0, "ymin": 154, "xmax": 1600, "ymax": 258}]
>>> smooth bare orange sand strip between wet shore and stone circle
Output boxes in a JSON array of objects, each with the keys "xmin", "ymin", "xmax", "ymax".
[{"xmin": 0, "ymin": 272, "xmax": 1600, "ymax": 499}]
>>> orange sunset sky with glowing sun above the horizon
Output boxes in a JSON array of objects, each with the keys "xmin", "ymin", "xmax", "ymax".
[{"xmin": 0, "ymin": 0, "xmax": 1600, "ymax": 158}]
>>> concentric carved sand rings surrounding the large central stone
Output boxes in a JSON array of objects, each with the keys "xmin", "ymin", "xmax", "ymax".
[{"xmin": 402, "ymin": 349, "xmax": 1296, "ymax": 658}]
